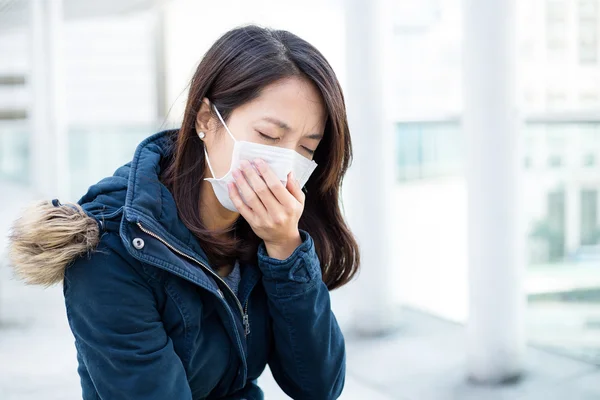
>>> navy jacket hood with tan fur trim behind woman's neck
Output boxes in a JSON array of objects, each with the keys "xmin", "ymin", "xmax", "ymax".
[{"xmin": 8, "ymin": 131, "xmax": 180, "ymax": 286}]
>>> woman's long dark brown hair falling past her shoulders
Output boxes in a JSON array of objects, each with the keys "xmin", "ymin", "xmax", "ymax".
[{"xmin": 162, "ymin": 25, "xmax": 360, "ymax": 289}]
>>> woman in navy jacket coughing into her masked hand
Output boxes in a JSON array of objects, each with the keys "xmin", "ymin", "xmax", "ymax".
[{"xmin": 10, "ymin": 26, "xmax": 359, "ymax": 400}]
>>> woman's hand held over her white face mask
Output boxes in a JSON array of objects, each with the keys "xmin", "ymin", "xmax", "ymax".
[{"xmin": 228, "ymin": 159, "xmax": 305, "ymax": 260}]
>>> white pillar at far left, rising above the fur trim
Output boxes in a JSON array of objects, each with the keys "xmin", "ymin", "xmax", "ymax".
[{"xmin": 29, "ymin": 0, "xmax": 70, "ymax": 200}]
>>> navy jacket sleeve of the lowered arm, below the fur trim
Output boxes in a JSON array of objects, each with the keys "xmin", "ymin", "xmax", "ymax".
[{"xmin": 64, "ymin": 234, "xmax": 192, "ymax": 400}]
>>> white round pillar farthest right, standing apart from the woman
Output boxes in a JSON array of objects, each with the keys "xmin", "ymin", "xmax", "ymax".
[{"xmin": 463, "ymin": 0, "xmax": 525, "ymax": 383}]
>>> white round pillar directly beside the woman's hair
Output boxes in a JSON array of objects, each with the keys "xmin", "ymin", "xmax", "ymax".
[{"xmin": 344, "ymin": 0, "xmax": 397, "ymax": 335}]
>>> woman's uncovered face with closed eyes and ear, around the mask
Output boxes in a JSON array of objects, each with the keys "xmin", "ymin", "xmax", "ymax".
[{"xmin": 196, "ymin": 77, "xmax": 327, "ymax": 178}]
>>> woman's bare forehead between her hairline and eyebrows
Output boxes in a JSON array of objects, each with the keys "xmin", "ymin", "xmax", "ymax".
[{"xmin": 236, "ymin": 77, "xmax": 327, "ymax": 133}]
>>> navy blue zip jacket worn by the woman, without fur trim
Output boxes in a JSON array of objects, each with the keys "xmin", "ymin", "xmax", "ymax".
[{"xmin": 64, "ymin": 131, "xmax": 345, "ymax": 400}]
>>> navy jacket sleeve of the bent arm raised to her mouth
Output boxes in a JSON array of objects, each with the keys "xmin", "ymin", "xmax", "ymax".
[{"xmin": 258, "ymin": 231, "xmax": 346, "ymax": 400}]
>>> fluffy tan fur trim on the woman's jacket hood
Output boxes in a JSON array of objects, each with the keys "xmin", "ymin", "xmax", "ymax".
[{"xmin": 8, "ymin": 200, "xmax": 100, "ymax": 287}]
